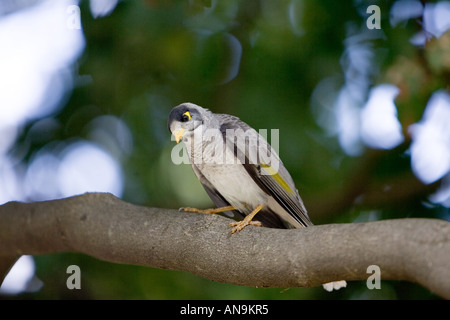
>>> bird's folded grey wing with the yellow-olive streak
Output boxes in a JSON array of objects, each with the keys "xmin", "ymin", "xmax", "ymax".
[{"xmin": 217, "ymin": 114, "xmax": 312, "ymax": 227}]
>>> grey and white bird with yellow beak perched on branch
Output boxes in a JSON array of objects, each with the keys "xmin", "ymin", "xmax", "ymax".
[{"xmin": 168, "ymin": 103, "xmax": 346, "ymax": 291}]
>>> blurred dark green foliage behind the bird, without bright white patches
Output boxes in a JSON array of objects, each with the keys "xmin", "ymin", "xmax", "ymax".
[{"xmin": 1, "ymin": 0, "xmax": 450, "ymax": 299}]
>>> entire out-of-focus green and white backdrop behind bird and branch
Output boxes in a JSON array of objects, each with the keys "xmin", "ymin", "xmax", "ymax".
[{"xmin": 0, "ymin": 0, "xmax": 450, "ymax": 299}]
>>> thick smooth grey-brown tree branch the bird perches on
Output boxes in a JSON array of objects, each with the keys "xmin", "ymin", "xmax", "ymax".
[{"xmin": 0, "ymin": 193, "xmax": 450, "ymax": 298}]
